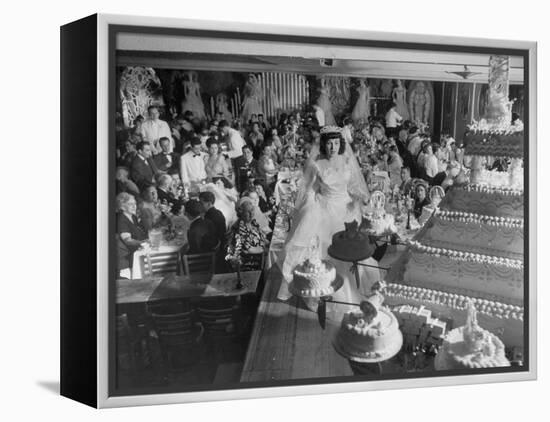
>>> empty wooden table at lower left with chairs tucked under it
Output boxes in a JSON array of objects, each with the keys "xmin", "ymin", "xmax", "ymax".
[{"xmin": 116, "ymin": 271, "xmax": 261, "ymax": 305}]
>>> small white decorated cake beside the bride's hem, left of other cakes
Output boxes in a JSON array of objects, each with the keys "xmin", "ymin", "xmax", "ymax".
[{"xmin": 290, "ymin": 258, "xmax": 336, "ymax": 296}]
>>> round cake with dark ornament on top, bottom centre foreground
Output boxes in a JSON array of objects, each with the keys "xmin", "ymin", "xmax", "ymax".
[{"xmin": 334, "ymin": 307, "xmax": 403, "ymax": 362}]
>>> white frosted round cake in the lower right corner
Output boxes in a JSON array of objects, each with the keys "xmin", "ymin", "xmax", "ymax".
[{"xmin": 435, "ymin": 326, "xmax": 510, "ymax": 370}]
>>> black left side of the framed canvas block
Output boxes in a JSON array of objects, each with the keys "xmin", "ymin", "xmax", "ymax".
[{"xmin": 60, "ymin": 15, "xmax": 98, "ymax": 407}]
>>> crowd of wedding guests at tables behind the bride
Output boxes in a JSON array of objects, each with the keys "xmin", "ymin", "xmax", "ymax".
[{"xmin": 116, "ymin": 106, "xmax": 474, "ymax": 277}]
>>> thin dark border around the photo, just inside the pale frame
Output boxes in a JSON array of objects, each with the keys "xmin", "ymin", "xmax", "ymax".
[{"xmin": 108, "ymin": 25, "xmax": 530, "ymax": 397}]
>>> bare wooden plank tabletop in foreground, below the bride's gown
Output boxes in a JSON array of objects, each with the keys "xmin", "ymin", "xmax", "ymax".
[{"xmin": 241, "ymin": 266, "xmax": 352, "ymax": 382}]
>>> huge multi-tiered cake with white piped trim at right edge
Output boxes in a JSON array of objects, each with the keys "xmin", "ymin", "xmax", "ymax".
[{"xmin": 386, "ymin": 132, "xmax": 525, "ymax": 360}]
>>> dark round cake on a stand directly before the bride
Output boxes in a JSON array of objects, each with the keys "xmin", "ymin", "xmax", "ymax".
[{"xmin": 329, "ymin": 221, "xmax": 374, "ymax": 262}]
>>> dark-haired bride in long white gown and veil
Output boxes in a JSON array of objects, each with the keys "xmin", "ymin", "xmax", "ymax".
[{"xmin": 278, "ymin": 127, "xmax": 381, "ymax": 312}]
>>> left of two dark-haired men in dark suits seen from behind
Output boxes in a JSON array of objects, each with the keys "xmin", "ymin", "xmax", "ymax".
[{"xmin": 185, "ymin": 199, "xmax": 218, "ymax": 254}]
